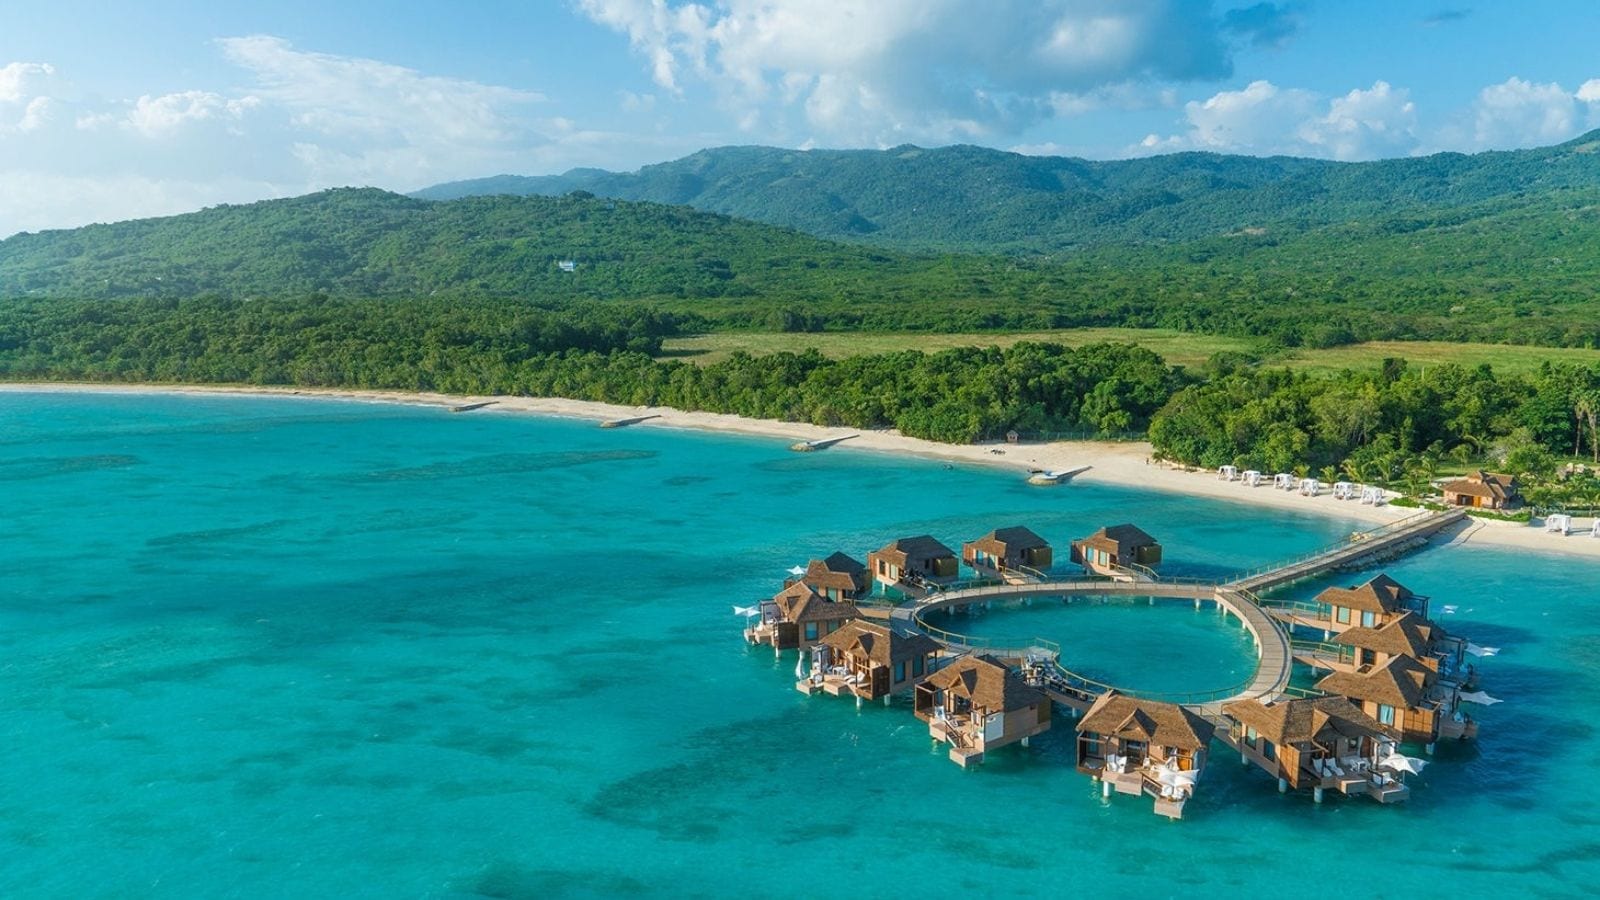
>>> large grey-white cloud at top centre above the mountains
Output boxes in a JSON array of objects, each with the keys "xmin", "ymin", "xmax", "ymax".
[{"xmin": 578, "ymin": 0, "xmax": 1232, "ymax": 144}]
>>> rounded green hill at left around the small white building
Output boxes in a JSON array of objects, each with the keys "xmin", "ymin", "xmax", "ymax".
[{"xmin": 0, "ymin": 189, "xmax": 947, "ymax": 301}]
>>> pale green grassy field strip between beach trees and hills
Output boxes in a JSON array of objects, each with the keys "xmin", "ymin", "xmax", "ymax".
[{"xmin": 661, "ymin": 328, "xmax": 1600, "ymax": 372}]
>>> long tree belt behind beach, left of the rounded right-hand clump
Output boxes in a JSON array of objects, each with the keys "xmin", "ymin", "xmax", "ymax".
[{"xmin": 0, "ymin": 298, "xmax": 1182, "ymax": 442}]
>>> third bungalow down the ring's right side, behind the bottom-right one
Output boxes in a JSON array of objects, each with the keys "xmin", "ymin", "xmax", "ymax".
[{"xmin": 1317, "ymin": 655, "xmax": 1478, "ymax": 753}]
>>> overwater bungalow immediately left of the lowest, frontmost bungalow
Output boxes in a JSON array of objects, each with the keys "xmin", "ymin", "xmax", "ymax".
[{"xmin": 915, "ymin": 655, "xmax": 1050, "ymax": 769}]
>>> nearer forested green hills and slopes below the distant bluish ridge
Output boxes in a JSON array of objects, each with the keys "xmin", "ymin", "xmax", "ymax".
[{"xmin": 9, "ymin": 183, "xmax": 1600, "ymax": 346}]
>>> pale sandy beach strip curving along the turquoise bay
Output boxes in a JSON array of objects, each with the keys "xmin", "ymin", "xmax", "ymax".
[{"xmin": 0, "ymin": 381, "xmax": 1600, "ymax": 559}]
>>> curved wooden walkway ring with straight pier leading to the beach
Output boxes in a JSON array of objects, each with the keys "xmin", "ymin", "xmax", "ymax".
[{"xmin": 888, "ymin": 509, "xmax": 1466, "ymax": 711}]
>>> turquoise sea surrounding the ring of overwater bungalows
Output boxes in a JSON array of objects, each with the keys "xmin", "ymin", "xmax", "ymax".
[{"xmin": 0, "ymin": 394, "xmax": 1600, "ymax": 897}]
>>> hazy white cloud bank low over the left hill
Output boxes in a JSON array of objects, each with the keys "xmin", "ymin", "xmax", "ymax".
[{"xmin": 0, "ymin": 35, "xmax": 675, "ymax": 237}]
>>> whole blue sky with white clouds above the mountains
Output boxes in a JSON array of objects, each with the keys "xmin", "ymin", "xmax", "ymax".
[{"xmin": 0, "ymin": 0, "xmax": 1600, "ymax": 235}]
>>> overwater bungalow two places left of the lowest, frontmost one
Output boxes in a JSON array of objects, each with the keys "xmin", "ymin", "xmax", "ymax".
[{"xmin": 795, "ymin": 618, "xmax": 942, "ymax": 703}]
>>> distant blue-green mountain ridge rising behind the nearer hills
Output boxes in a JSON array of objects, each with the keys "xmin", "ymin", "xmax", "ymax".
[{"xmin": 418, "ymin": 131, "xmax": 1600, "ymax": 255}]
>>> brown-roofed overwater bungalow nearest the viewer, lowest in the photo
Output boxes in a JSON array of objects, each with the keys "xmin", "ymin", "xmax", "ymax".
[{"xmin": 1077, "ymin": 690, "xmax": 1216, "ymax": 818}]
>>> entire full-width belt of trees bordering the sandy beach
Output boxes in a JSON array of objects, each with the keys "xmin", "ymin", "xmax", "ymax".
[{"xmin": 0, "ymin": 296, "xmax": 1600, "ymax": 506}]
